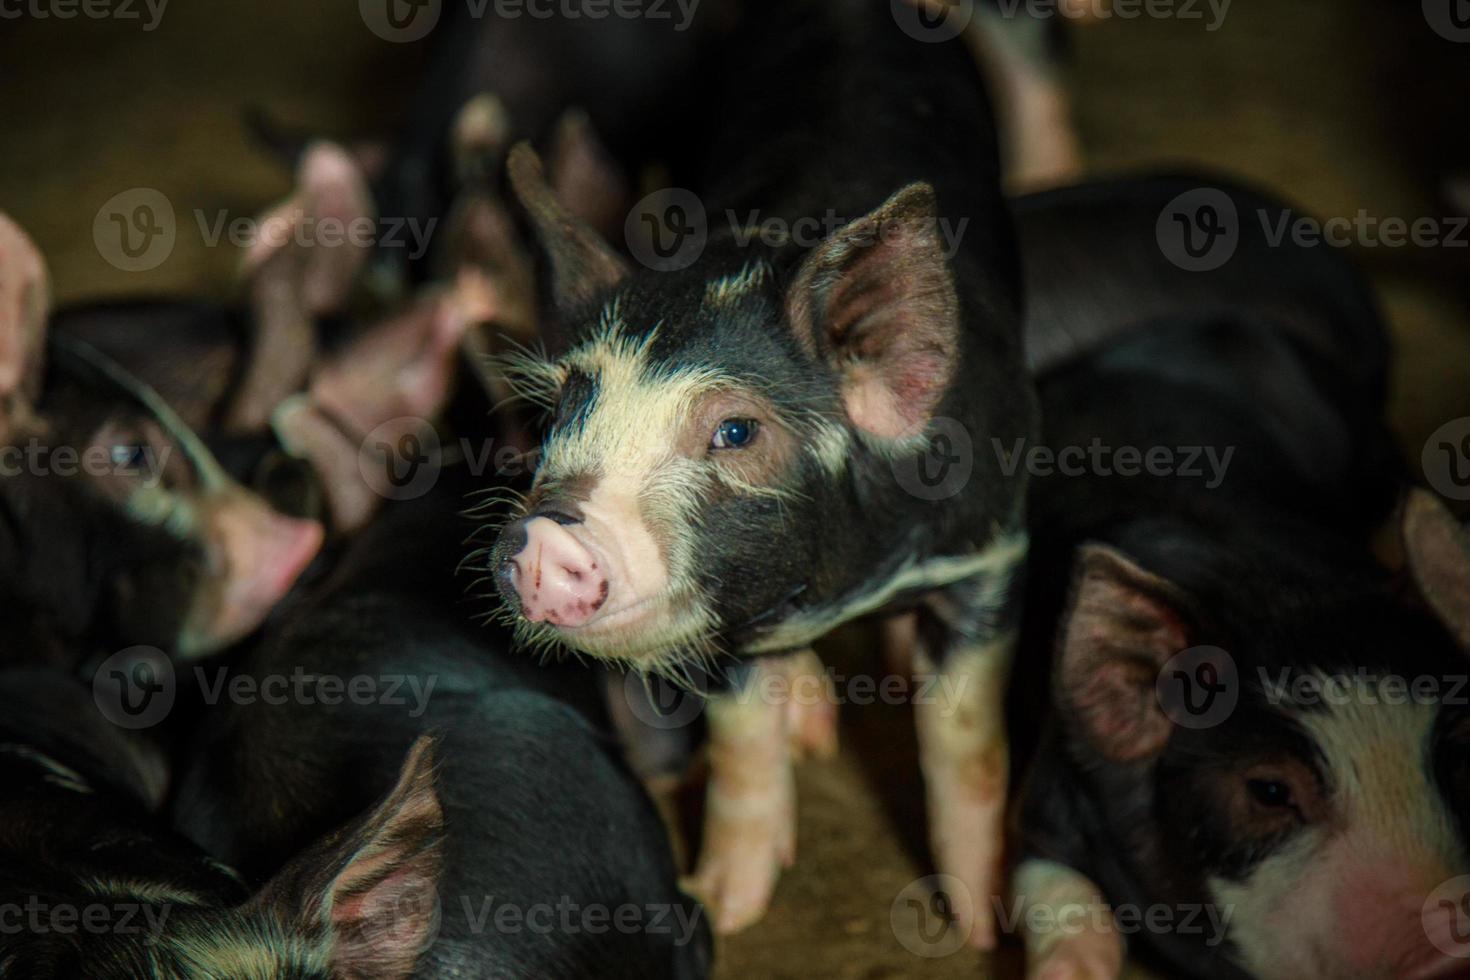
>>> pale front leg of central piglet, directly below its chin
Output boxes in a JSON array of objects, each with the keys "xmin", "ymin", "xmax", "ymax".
[{"xmin": 685, "ymin": 660, "xmax": 797, "ymax": 933}]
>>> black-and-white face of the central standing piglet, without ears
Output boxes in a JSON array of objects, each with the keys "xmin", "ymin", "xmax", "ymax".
[{"xmin": 491, "ymin": 318, "xmax": 816, "ymax": 667}]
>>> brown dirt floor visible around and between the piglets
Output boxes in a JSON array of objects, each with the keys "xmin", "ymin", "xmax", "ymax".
[{"xmin": 0, "ymin": 0, "xmax": 1470, "ymax": 980}]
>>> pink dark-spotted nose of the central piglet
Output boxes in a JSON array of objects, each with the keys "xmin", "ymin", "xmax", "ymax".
[{"xmin": 501, "ymin": 517, "xmax": 607, "ymax": 626}]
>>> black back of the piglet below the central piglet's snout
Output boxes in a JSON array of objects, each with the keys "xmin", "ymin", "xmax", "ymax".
[{"xmin": 175, "ymin": 473, "xmax": 709, "ymax": 979}]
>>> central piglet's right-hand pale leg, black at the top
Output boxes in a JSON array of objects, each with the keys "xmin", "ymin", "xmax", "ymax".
[{"xmin": 914, "ymin": 567, "xmax": 1016, "ymax": 949}]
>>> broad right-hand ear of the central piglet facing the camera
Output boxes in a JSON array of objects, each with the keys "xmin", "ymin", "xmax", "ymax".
[{"xmin": 789, "ymin": 184, "xmax": 960, "ymax": 439}]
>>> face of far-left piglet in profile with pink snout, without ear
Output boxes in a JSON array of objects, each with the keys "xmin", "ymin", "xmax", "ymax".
[{"xmin": 25, "ymin": 348, "xmax": 322, "ymax": 655}]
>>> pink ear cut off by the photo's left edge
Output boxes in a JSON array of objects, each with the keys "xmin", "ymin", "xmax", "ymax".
[{"xmin": 0, "ymin": 215, "xmax": 51, "ymax": 411}]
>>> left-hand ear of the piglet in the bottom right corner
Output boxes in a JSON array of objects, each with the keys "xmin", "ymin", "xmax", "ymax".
[{"xmin": 1057, "ymin": 545, "xmax": 1189, "ymax": 763}]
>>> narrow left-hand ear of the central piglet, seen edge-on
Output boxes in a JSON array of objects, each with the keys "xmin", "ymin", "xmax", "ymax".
[{"xmin": 506, "ymin": 143, "xmax": 628, "ymax": 314}]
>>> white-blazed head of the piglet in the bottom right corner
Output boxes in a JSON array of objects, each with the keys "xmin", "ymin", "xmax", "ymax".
[{"xmin": 1057, "ymin": 548, "xmax": 1470, "ymax": 980}]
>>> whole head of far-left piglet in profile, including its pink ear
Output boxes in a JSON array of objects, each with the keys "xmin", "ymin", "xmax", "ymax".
[{"xmin": 0, "ymin": 211, "xmax": 322, "ymax": 661}]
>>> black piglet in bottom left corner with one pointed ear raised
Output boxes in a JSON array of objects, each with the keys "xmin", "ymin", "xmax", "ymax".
[{"xmin": 0, "ymin": 669, "xmax": 447, "ymax": 980}]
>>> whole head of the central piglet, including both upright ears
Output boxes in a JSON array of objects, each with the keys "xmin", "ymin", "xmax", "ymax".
[{"xmin": 484, "ymin": 147, "xmax": 1026, "ymax": 670}]
